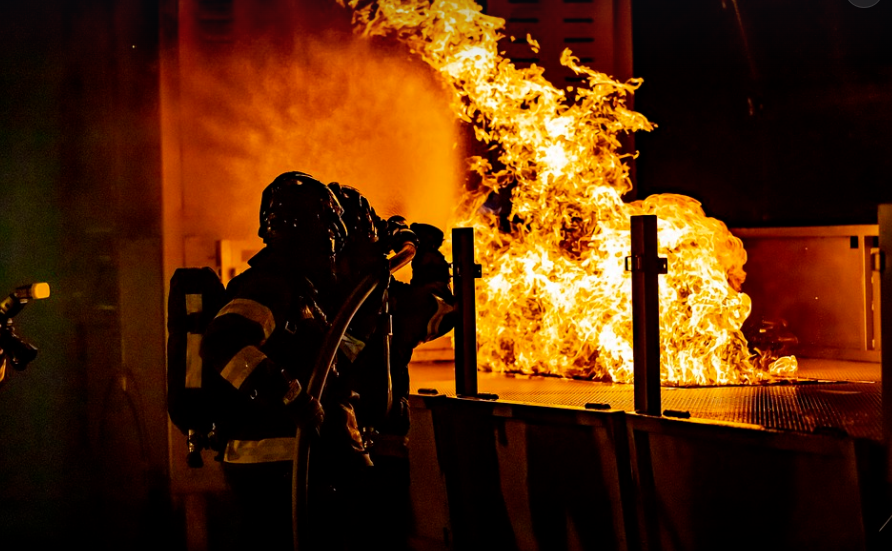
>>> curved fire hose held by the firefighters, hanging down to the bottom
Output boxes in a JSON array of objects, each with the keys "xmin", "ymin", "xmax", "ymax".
[{"xmin": 291, "ymin": 243, "xmax": 416, "ymax": 551}]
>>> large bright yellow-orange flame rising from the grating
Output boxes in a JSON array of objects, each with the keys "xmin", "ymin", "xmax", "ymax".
[{"xmin": 338, "ymin": 0, "xmax": 796, "ymax": 385}]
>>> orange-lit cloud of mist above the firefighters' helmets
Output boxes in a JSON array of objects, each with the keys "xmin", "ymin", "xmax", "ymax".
[{"xmin": 180, "ymin": 3, "xmax": 463, "ymax": 250}]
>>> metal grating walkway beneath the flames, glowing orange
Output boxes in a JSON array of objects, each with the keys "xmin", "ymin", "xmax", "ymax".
[{"xmin": 410, "ymin": 359, "xmax": 883, "ymax": 441}]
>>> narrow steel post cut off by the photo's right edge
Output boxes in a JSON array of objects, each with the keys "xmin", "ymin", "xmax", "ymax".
[{"xmin": 873, "ymin": 204, "xmax": 892, "ymax": 482}]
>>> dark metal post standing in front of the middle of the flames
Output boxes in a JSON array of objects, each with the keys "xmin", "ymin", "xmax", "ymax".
[{"xmin": 626, "ymin": 215, "xmax": 667, "ymax": 415}]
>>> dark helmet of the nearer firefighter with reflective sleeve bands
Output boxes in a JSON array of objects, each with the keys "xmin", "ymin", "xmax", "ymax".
[{"xmin": 258, "ymin": 172, "xmax": 347, "ymax": 256}]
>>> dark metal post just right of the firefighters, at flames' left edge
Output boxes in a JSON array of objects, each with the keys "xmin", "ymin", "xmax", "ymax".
[{"xmin": 452, "ymin": 228, "xmax": 481, "ymax": 396}]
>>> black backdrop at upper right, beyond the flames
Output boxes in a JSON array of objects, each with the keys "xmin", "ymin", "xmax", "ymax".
[{"xmin": 632, "ymin": 0, "xmax": 892, "ymax": 227}]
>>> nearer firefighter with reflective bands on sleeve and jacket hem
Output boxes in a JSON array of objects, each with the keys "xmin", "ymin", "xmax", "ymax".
[{"xmin": 201, "ymin": 172, "xmax": 371, "ymax": 549}]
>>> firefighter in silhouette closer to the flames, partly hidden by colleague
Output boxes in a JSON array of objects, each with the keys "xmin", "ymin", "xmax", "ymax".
[{"xmin": 329, "ymin": 183, "xmax": 455, "ymax": 550}]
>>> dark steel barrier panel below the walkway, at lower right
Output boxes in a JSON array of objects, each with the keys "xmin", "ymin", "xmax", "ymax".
[{"xmin": 626, "ymin": 413, "xmax": 866, "ymax": 551}]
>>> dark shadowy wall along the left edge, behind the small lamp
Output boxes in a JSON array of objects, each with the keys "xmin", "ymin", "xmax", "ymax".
[{"xmin": 0, "ymin": 0, "xmax": 173, "ymax": 550}]
